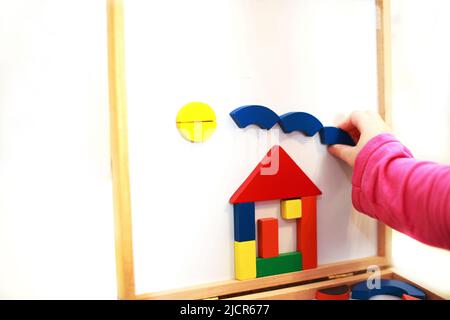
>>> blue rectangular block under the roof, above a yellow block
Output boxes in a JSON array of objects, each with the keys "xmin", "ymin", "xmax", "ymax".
[{"xmin": 234, "ymin": 202, "xmax": 256, "ymax": 242}]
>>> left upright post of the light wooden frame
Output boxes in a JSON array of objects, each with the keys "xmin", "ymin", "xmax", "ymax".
[{"xmin": 107, "ymin": 0, "xmax": 135, "ymax": 299}]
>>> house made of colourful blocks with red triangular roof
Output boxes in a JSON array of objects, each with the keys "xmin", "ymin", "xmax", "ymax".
[{"xmin": 230, "ymin": 146, "xmax": 321, "ymax": 280}]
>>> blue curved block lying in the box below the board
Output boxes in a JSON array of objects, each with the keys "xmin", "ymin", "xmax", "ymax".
[{"xmin": 352, "ymin": 279, "xmax": 426, "ymax": 300}]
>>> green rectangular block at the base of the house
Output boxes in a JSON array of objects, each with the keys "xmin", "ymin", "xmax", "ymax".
[{"xmin": 256, "ymin": 252, "xmax": 302, "ymax": 278}]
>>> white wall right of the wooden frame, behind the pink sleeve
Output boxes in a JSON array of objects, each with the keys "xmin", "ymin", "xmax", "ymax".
[{"xmin": 392, "ymin": 0, "xmax": 450, "ymax": 298}]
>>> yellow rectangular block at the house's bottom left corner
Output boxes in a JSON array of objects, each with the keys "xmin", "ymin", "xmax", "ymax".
[{"xmin": 234, "ymin": 240, "xmax": 256, "ymax": 280}]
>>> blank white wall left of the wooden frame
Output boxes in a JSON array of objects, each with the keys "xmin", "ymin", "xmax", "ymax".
[{"xmin": 0, "ymin": 0, "xmax": 116, "ymax": 299}]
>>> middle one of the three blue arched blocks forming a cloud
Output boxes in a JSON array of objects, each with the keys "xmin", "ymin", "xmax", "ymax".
[{"xmin": 280, "ymin": 112, "xmax": 323, "ymax": 137}]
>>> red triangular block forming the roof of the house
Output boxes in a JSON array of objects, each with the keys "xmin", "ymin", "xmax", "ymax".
[{"xmin": 230, "ymin": 146, "xmax": 322, "ymax": 204}]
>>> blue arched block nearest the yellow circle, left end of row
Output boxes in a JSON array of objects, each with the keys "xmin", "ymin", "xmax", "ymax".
[{"xmin": 230, "ymin": 105, "xmax": 280, "ymax": 130}]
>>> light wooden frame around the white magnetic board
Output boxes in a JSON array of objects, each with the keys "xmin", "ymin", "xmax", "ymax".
[{"xmin": 107, "ymin": 0, "xmax": 393, "ymax": 299}]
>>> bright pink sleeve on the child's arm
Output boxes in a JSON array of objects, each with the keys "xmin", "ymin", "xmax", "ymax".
[{"xmin": 352, "ymin": 134, "xmax": 450, "ymax": 249}]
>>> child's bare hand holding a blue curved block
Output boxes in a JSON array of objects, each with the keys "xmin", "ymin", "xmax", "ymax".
[{"xmin": 328, "ymin": 111, "xmax": 391, "ymax": 167}]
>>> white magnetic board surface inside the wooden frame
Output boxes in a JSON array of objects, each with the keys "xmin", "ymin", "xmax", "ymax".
[{"xmin": 125, "ymin": 0, "xmax": 377, "ymax": 294}]
